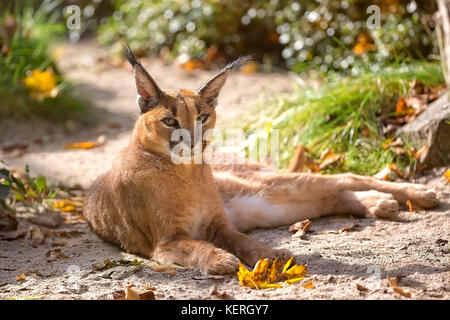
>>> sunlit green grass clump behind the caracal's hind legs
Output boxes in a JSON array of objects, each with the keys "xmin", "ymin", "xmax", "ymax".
[{"xmin": 234, "ymin": 62, "xmax": 444, "ymax": 175}]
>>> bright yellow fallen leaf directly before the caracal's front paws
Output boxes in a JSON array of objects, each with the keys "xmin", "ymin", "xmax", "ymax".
[{"xmin": 237, "ymin": 258, "xmax": 307, "ymax": 289}]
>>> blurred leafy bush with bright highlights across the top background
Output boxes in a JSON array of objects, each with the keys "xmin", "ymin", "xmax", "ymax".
[{"xmin": 99, "ymin": 0, "xmax": 438, "ymax": 72}]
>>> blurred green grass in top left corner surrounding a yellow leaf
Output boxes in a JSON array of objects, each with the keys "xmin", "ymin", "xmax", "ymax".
[{"xmin": 0, "ymin": 1, "xmax": 85, "ymax": 121}]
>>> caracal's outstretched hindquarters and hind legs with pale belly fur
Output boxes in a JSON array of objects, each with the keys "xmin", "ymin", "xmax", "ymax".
[{"xmin": 214, "ymin": 170, "xmax": 438, "ymax": 231}]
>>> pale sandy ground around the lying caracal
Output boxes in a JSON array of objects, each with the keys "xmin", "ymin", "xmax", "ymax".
[{"xmin": 0, "ymin": 43, "xmax": 450, "ymax": 299}]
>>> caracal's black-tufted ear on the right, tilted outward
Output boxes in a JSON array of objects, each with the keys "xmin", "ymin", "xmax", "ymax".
[{"xmin": 195, "ymin": 56, "xmax": 253, "ymax": 108}]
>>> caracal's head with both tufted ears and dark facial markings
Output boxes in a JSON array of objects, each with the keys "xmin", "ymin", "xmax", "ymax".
[{"xmin": 124, "ymin": 46, "xmax": 250, "ymax": 159}]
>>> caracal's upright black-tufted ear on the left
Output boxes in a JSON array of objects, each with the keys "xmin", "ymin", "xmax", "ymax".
[{"xmin": 123, "ymin": 44, "xmax": 164, "ymax": 113}]
